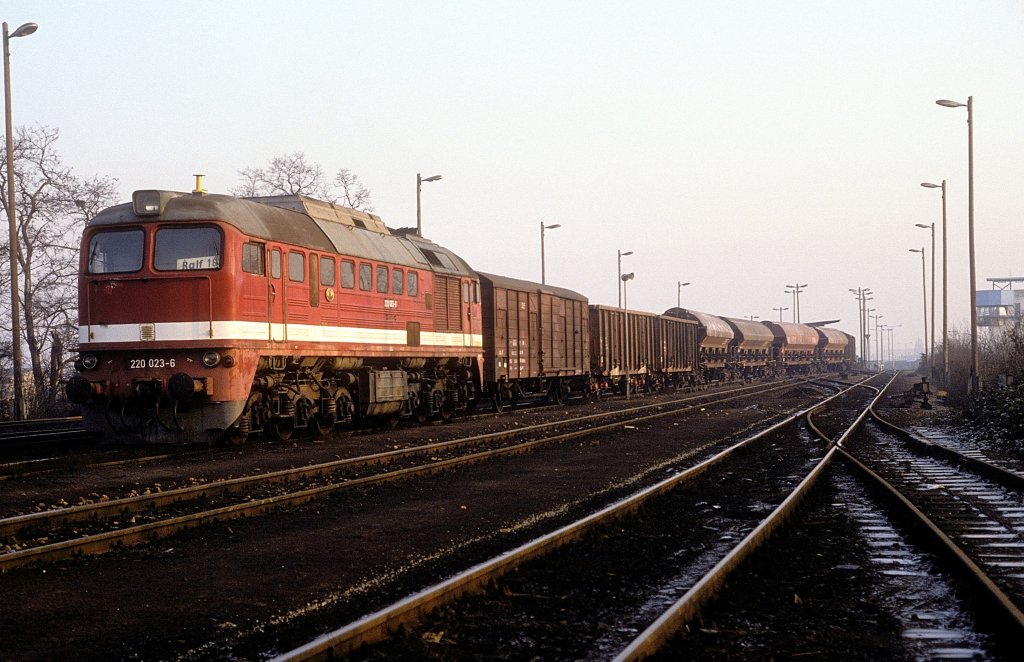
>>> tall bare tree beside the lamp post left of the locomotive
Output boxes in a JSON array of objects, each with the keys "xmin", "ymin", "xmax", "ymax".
[{"xmin": 0, "ymin": 126, "xmax": 117, "ymax": 413}]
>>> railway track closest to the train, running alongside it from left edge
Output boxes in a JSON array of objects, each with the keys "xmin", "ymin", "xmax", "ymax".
[{"xmin": 0, "ymin": 380, "xmax": 815, "ymax": 571}]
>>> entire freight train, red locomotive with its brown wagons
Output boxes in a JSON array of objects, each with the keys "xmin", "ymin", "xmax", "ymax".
[{"xmin": 66, "ymin": 190, "xmax": 854, "ymax": 442}]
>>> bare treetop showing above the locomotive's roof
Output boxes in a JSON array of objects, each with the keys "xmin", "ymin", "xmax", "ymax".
[{"xmin": 230, "ymin": 152, "xmax": 373, "ymax": 211}]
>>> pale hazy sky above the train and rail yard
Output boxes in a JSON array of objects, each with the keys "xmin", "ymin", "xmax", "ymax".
[{"xmin": 8, "ymin": 0, "xmax": 1024, "ymax": 353}]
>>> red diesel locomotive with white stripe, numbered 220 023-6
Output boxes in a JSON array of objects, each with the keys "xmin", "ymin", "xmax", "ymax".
[{"xmin": 68, "ymin": 191, "xmax": 481, "ymax": 441}]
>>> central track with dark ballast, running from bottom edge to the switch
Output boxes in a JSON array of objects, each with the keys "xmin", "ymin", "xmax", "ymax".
[{"xmin": 266, "ymin": 377, "xmax": 877, "ymax": 660}]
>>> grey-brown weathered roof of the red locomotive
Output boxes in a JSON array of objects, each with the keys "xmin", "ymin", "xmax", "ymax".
[{"xmin": 89, "ymin": 192, "xmax": 473, "ymax": 276}]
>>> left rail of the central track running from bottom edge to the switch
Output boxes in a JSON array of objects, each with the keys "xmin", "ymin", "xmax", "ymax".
[{"xmin": 274, "ymin": 377, "xmax": 872, "ymax": 662}]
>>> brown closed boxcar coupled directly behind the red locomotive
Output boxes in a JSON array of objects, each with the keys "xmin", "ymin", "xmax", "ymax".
[{"xmin": 478, "ymin": 273, "xmax": 590, "ymax": 411}]
